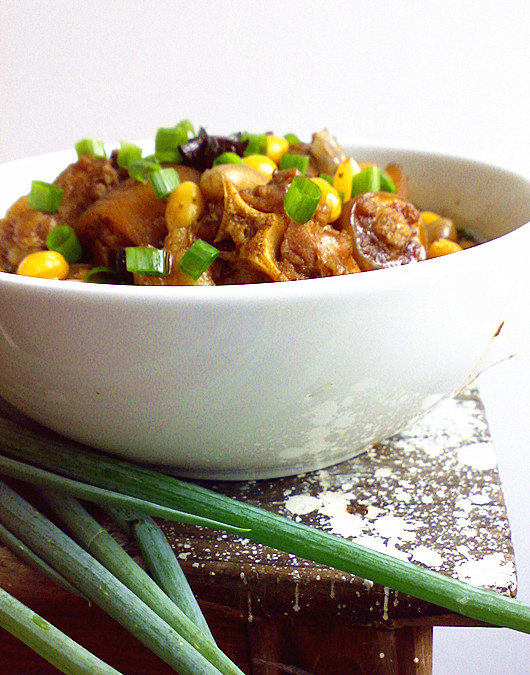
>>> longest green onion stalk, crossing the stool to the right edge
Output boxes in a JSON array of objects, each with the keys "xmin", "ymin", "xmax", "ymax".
[{"xmin": 0, "ymin": 419, "xmax": 530, "ymax": 633}]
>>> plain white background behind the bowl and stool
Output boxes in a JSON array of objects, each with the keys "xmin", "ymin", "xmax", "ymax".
[{"xmin": 0, "ymin": 0, "xmax": 530, "ymax": 675}]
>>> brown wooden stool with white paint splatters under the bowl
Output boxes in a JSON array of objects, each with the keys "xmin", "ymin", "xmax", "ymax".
[{"xmin": 0, "ymin": 390, "xmax": 516, "ymax": 675}]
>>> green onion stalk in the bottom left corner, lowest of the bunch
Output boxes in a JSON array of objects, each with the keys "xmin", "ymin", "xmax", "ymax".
[{"xmin": 0, "ymin": 588, "xmax": 120, "ymax": 675}]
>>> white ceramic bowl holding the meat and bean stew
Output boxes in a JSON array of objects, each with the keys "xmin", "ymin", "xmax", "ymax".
[{"xmin": 0, "ymin": 147, "xmax": 530, "ymax": 479}]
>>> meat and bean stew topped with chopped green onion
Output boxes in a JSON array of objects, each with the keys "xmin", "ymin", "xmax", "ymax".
[{"xmin": 0, "ymin": 122, "xmax": 473, "ymax": 286}]
